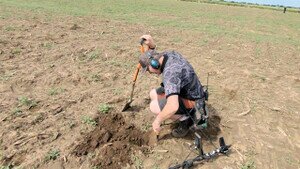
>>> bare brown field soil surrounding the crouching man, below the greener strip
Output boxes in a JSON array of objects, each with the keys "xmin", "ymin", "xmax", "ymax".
[{"xmin": 0, "ymin": 6, "xmax": 300, "ymax": 169}]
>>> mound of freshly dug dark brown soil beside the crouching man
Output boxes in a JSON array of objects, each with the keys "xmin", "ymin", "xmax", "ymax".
[{"xmin": 73, "ymin": 114, "xmax": 149, "ymax": 169}]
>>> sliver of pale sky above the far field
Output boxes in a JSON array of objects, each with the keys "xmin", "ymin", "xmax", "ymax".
[{"xmin": 226, "ymin": 0, "xmax": 300, "ymax": 8}]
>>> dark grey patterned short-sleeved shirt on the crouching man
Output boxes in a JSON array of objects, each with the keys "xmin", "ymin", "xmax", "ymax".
[{"xmin": 161, "ymin": 51, "xmax": 204, "ymax": 100}]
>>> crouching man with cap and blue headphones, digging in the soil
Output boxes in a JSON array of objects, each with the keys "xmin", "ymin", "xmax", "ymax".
[{"xmin": 139, "ymin": 35, "xmax": 205, "ymax": 138}]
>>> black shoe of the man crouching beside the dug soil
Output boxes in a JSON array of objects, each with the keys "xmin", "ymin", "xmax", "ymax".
[{"xmin": 172, "ymin": 118, "xmax": 193, "ymax": 138}]
